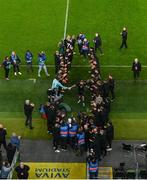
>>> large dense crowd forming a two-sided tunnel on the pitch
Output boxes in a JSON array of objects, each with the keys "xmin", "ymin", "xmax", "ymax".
[{"xmin": 34, "ymin": 34, "xmax": 115, "ymax": 179}]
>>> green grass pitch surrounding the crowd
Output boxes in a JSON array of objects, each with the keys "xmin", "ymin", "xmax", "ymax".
[{"xmin": 0, "ymin": 0, "xmax": 147, "ymax": 139}]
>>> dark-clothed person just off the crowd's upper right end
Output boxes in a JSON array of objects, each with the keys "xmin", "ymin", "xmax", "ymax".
[{"xmin": 93, "ymin": 33, "xmax": 104, "ymax": 55}]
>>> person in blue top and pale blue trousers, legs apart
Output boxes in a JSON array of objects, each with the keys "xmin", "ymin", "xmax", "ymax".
[{"xmin": 38, "ymin": 51, "xmax": 50, "ymax": 77}]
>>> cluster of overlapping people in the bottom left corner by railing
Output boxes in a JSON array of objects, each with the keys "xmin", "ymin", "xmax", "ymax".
[{"xmin": 0, "ymin": 124, "xmax": 21, "ymax": 179}]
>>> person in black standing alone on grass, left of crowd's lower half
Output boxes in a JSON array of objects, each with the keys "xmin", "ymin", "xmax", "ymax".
[{"xmin": 24, "ymin": 100, "xmax": 34, "ymax": 129}]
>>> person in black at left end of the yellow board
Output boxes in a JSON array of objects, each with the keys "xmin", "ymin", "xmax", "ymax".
[{"xmin": 15, "ymin": 162, "xmax": 30, "ymax": 179}]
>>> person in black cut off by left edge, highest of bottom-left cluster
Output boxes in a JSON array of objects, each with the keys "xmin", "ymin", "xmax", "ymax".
[{"xmin": 0, "ymin": 124, "xmax": 7, "ymax": 149}]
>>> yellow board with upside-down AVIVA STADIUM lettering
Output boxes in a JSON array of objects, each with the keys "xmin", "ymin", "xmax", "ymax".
[{"xmin": 25, "ymin": 163, "xmax": 86, "ymax": 179}]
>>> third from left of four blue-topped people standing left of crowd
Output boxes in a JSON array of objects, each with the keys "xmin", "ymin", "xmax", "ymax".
[{"xmin": 25, "ymin": 50, "xmax": 33, "ymax": 72}]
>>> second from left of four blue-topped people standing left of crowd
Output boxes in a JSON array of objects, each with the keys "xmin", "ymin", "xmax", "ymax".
[{"xmin": 10, "ymin": 51, "xmax": 22, "ymax": 76}]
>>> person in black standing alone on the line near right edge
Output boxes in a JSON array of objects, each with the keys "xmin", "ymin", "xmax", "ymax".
[{"xmin": 132, "ymin": 58, "xmax": 141, "ymax": 80}]
